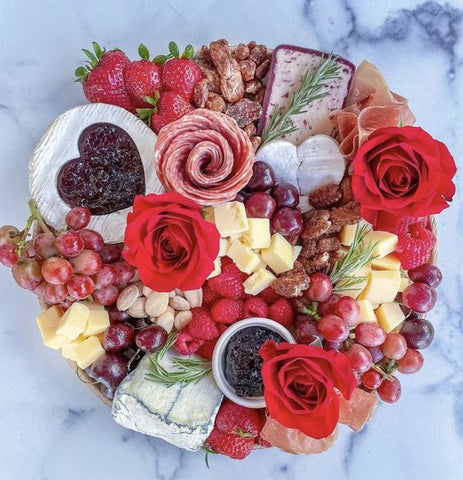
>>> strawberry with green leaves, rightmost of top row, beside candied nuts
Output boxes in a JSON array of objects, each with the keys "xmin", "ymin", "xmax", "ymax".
[{"xmin": 155, "ymin": 42, "xmax": 203, "ymax": 102}]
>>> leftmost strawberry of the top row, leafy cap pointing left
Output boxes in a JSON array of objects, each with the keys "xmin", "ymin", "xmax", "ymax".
[{"xmin": 75, "ymin": 42, "xmax": 135, "ymax": 112}]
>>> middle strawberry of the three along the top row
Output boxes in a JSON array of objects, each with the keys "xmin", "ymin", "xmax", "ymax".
[{"xmin": 124, "ymin": 43, "xmax": 162, "ymax": 107}]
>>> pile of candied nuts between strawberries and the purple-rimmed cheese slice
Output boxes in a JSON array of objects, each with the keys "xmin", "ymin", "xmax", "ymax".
[{"xmin": 193, "ymin": 40, "xmax": 270, "ymax": 150}]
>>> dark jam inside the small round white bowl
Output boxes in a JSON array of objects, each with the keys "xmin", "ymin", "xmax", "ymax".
[{"xmin": 224, "ymin": 327, "xmax": 284, "ymax": 397}]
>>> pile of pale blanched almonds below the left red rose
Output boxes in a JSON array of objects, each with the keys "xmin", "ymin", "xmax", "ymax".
[{"xmin": 117, "ymin": 282, "xmax": 203, "ymax": 333}]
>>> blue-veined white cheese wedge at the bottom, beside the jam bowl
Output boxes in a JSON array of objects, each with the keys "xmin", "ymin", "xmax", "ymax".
[{"xmin": 112, "ymin": 355, "xmax": 223, "ymax": 451}]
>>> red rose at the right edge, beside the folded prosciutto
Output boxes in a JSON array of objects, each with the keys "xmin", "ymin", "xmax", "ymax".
[{"xmin": 352, "ymin": 127, "xmax": 456, "ymax": 229}]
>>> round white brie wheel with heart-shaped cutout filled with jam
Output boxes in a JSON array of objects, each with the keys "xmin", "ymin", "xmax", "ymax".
[{"xmin": 29, "ymin": 103, "xmax": 164, "ymax": 243}]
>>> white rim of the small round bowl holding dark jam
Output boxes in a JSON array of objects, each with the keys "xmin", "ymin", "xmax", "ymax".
[{"xmin": 212, "ymin": 317, "xmax": 296, "ymax": 408}]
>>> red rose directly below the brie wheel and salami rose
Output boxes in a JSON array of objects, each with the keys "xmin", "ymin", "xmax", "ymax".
[{"xmin": 123, "ymin": 193, "xmax": 220, "ymax": 292}]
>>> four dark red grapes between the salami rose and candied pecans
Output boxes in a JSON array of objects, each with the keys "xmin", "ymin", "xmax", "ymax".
[{"xmin": 236, "ymin": 161, "xmax": 303, "ymax": 237}]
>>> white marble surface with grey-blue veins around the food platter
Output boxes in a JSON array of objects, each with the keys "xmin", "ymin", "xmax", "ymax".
[{"xmin": 0, "ymin": 0, "xmax": 463, "ymax": 480}]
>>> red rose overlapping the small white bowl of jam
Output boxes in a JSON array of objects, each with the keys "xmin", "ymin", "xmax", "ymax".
[{"xmin": 259, "ymin": 340, "xmax": 357, "ymax": 438}]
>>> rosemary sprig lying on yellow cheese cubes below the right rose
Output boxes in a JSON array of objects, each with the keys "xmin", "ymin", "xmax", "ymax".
[{"xmin": 330, "ymin": 224, "xmax": 376, "ymax": 292}]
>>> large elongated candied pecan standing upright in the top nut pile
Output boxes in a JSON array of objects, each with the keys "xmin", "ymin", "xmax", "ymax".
[{"xmin": 210, "ymin": 40, "xmax": 249, "ymax": 102}]
